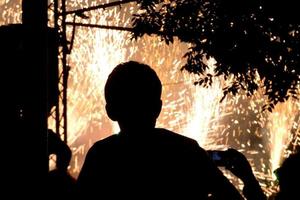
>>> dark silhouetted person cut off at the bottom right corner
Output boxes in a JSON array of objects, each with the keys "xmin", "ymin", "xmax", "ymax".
[{"xmin": 275, "ymin": 149, "xmax": 300, "ymax": 200}]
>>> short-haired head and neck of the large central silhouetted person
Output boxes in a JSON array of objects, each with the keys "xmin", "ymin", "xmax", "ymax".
[{"xmin": 105, "ymin": 61, "xmax": 162, "ymax": 132}]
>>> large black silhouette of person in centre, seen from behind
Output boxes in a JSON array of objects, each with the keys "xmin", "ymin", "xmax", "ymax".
[{"xmin": 77, "ymin": 61, "xmax": 242, "ymax": 200}]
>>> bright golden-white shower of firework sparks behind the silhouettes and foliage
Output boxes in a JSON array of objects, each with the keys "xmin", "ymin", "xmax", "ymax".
[{"xmin": 0, "ymin": 0, "xmax": 300, "ymax": 197}]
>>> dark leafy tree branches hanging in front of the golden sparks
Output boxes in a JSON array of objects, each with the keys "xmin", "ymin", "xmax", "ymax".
[{"xmin": 132, "ymin": 0, "xmax": 300, "ymax": 111}]
